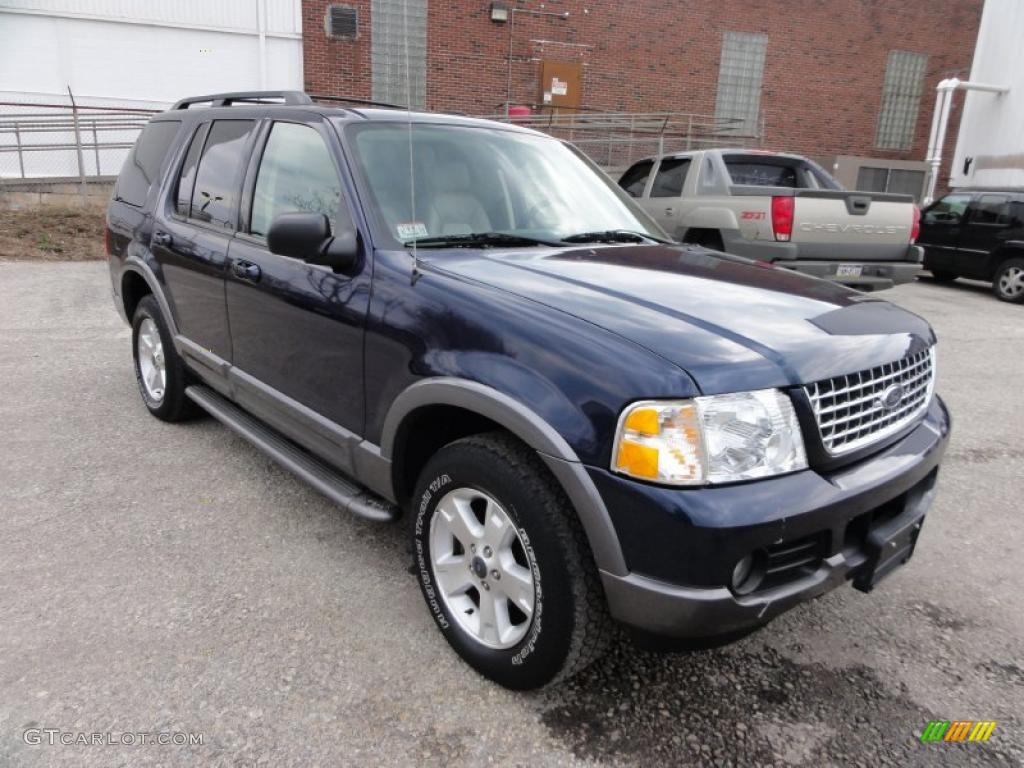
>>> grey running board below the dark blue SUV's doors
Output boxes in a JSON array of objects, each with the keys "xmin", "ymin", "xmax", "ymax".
[{"xmin": 185, "ymin": 385, "xmax": 399, "ymax": 522}]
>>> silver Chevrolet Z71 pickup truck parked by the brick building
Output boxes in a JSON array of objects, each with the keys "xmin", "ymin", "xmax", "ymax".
[{"xmin": 618, "ymin": 150, "xmax": 924, "ymax": 290}]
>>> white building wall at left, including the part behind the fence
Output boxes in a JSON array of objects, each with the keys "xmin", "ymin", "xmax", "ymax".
[{"xmin": 0, "ymin": 0, "xmax": 303, "ymax": 179}]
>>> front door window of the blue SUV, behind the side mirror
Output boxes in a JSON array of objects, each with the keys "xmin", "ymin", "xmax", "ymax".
[{"xmin": 250, "ymin": 123, "xmax": 341, "ymax": 237}]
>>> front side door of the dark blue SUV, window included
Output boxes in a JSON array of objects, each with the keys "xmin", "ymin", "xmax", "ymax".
[{"xmin": 226, "ymin": 121, "xmax": 370, "ymax": 454}]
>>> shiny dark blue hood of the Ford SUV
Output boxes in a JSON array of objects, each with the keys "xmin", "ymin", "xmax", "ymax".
[{"xmin": 428, "ymin": 245, "xmax": 935, "ymax": 394}]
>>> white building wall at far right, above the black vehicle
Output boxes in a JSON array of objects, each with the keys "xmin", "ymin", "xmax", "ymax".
[{"xmin": 952, "ymin": 0, "xmax": 1024, "ymax": 186}]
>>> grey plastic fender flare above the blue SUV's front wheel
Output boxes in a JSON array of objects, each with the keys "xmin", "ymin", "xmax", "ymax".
[{"xmin": 381, "ymin": 377, "xmax": 629, "ymax": 575}]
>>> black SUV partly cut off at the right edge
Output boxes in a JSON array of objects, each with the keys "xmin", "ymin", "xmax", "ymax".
[{"xmin": 918, "ymin": 189, "xmax": 1024, "ymax": 304}]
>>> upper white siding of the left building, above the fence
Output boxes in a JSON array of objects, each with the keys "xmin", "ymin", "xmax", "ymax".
[{"xmin": 0, "ymin": 0, "xmax": 302, "ymax": 108}]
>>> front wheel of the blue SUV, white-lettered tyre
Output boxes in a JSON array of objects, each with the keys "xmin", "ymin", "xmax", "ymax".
[{"xmin": 413, "ymin": 432, "xmax": 610, "ymax": 690}]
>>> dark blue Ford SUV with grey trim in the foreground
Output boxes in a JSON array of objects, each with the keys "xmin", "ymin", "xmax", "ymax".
[{"xmin": 108, "ymin": 92, "xmax": 949, "ymax": 688}]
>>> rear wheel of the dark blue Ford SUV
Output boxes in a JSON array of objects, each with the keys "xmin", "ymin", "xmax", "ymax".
[{"xmin": 131, "ymin": 294, "xmax": 196, "ymax": 422}]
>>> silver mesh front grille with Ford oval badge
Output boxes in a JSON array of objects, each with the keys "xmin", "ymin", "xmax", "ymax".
[{"xmin": 805, "ymin": 347, "xmax": 935, "ymax": 456}]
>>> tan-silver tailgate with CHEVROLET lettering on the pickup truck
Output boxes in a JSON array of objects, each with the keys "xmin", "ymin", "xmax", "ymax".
[{"xmin": 791, "ymin": 189, "xmax": 913, "ymax": 261}]
